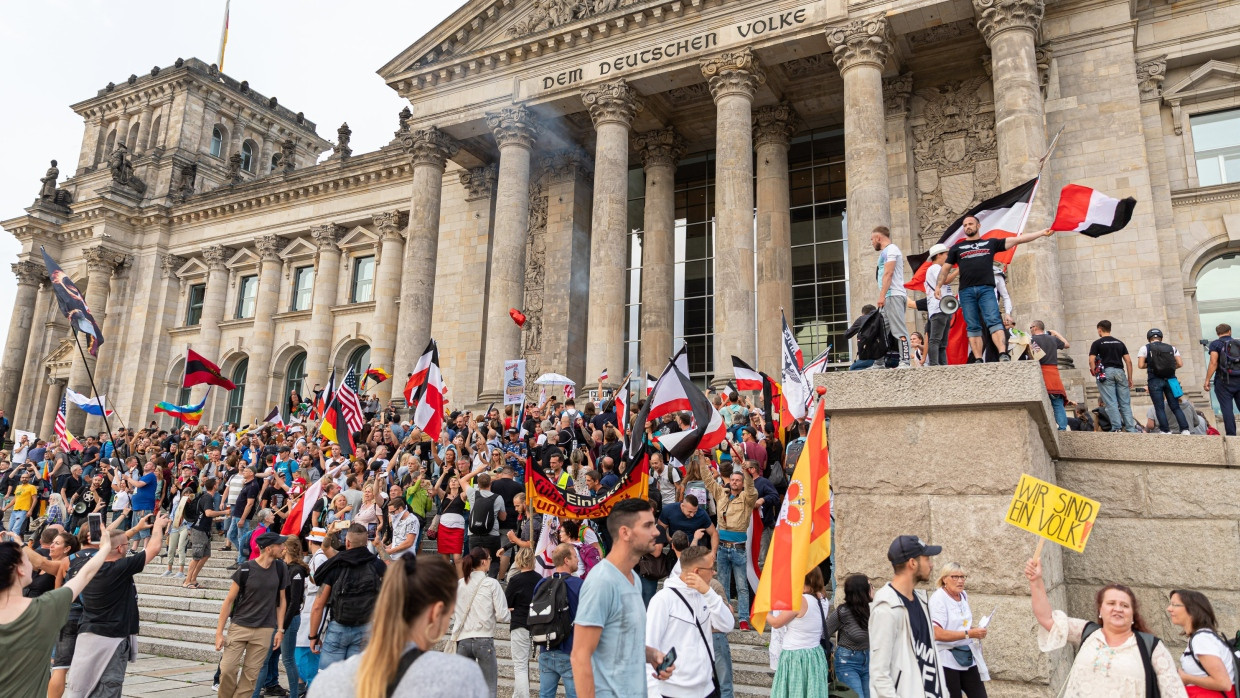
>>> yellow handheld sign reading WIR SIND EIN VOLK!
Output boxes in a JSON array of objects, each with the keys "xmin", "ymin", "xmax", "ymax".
[{"xmin": 1004, "ymin": 475, "xmax": 1099, "ymax": 553}]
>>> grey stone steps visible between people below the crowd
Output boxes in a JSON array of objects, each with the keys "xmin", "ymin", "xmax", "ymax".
[{"xmin": 134, "ymin": 544, "xmax": 774, "ymax": 698}]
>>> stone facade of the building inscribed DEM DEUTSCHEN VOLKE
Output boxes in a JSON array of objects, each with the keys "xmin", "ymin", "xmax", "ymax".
[{"xmin": 0, "ymin": 0, "xmax": 1240, "ymax": 430}]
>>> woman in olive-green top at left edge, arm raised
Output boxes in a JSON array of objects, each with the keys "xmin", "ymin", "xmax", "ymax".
[{"xmin": 0, "ymin": 532, "xmax": 112, "ymax": 698}]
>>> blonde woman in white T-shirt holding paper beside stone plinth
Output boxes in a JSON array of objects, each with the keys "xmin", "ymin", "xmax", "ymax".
[{"xmin": 930, "ymin": 563, "xmax": 991, "ymax": 698}]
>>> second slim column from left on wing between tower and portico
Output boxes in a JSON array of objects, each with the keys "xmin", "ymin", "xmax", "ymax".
[{"xmin": 241, "ymin": 236, "xmax": 289, "ymax": 424}]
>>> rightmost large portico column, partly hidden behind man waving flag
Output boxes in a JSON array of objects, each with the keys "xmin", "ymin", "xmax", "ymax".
[{"xmin": 973, "ymin": 0, "xmax": 1064, "ymax": 327}]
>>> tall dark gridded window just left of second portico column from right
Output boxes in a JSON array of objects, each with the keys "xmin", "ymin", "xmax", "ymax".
[{"xmin": 789, "ymin": 129, "xmax": 848, "ymax": 363}]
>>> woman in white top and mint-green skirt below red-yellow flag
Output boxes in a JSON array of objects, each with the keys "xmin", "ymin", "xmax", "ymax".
[{"xmin": 768, "ymin": 568, "xmax": 830, "ymax": 698}]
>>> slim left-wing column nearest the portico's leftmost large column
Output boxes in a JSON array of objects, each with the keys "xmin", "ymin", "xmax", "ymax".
[{"xmin": 371, "ymin": 211, "xmax": 412, "ymax": 407}]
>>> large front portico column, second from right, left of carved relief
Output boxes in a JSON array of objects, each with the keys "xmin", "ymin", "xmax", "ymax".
[{"xmin": 827, "ymin": 16, "xmax": 893, "ymax": 317}]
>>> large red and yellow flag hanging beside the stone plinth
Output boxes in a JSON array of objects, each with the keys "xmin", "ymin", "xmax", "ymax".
[{"xmin": 753, "ymin": 400, "xmax": 831, "ymax": 632}]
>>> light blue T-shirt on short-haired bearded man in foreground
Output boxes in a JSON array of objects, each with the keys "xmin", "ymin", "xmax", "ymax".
[{"xmin": 575, "ymin": 560, "xmax": 646, "ymax": 698}]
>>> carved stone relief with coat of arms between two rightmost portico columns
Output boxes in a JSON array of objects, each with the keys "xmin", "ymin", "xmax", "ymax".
[{"xmin": 913, "ymin": 76, "xmax": 999, "ymax": 244}]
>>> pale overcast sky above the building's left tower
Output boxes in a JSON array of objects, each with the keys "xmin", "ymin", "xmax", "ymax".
[{"xmin": 0, "ymin": 0, "xmax": 464, "ymax": 371}]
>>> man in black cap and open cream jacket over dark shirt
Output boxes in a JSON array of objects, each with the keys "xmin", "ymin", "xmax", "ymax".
[{"xmin": 869, "ymin": 536, "xmax": 947, "ymax": 698}]
